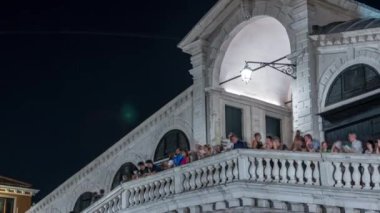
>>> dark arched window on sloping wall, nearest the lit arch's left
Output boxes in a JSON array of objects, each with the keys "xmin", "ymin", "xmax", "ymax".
[{"xmin": 154, "ymin": 130, "xmax": 190, "ymax": 161}]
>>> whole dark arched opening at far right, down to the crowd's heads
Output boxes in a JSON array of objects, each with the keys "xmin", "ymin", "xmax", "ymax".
[{"xmin": 321, "ymin": 64, "xmax": 380, "ymax": 143}]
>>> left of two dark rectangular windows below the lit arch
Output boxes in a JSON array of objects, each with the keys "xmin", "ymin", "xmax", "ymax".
[{"xmin": 225, "ymin": 105, "xmax": 243, "ymax": 138}]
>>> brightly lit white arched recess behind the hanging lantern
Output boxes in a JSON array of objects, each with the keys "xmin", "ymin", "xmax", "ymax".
[{"xmin": 219, "ymin": 16, "xmax": 292, "ymax": 106}]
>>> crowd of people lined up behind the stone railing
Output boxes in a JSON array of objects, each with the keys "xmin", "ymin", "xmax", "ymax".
[{"xmin": 119, "ymin": 131, "xmax": 380, "ymax": 182}]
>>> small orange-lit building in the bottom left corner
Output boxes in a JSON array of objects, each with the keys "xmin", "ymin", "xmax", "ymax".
[{"xmin": 0, "ymin": 176, "xmax": 38, "ymax": 213}]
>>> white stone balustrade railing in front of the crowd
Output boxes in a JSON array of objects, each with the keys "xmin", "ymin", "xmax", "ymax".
[{"xmin": 84, "ymin": 150, "xmax": 380, "ymax": 213}]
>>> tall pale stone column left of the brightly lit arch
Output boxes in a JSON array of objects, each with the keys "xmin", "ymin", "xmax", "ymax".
[{"xmin": 183, "ymin": 40, "xmax": 208, "ymax": 144}]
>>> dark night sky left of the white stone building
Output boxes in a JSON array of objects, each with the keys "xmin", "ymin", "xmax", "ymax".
[{"xmin": 0, "ymin": 0, "xmax": 380, "ymax": 201}]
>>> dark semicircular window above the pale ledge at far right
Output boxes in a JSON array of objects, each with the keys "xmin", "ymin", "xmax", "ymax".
[{"xmin": 326, "ymin": 64, "xmax": 380, "ymax": 106}]
